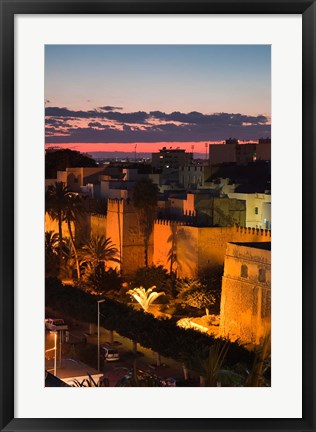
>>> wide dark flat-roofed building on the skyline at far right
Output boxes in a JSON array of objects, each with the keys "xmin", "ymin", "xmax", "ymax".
[{"xmin": 209, "ymin": 138, "xmax": 271, "ymax": 165}]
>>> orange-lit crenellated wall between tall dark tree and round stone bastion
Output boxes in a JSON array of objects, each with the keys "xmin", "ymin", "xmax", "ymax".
[{"xmin": 153, "ymin": 220, "xmax": 271, "ymax": 278}]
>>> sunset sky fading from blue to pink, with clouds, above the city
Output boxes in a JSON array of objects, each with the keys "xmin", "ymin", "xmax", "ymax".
[{"xmin": 45, "ymin": 45, "xmax": 271, "ymax": 152}]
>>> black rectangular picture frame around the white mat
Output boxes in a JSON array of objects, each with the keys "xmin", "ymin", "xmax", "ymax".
[{"xmin": 0, "ymin": 0, "xmax": 316, "ymax": 431}]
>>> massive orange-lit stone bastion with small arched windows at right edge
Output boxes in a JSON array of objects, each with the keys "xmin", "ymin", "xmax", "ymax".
[{"xmin": 220, "ymin": 243, "xmax": 271, "ymax": 344}]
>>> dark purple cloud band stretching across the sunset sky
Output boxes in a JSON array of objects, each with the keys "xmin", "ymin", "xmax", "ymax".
[{"xmin": 45, "ymin": 106, "xmax": 271, "ymax": 143}]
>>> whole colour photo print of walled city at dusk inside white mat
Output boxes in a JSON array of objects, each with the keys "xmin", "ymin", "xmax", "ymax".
[{"xmin": 43, "ymin": 45, "xmax": 273, "ymax": 387}]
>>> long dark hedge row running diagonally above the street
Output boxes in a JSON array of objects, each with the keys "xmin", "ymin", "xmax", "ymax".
[{"xmin": 45, "ymin": 278, "xmax": 254, "ymax": 366}]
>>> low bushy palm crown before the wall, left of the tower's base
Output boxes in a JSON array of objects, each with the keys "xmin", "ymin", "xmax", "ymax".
[{"xmin": 79, "ymin": 235, "xmax": 120, "ymax": 272}]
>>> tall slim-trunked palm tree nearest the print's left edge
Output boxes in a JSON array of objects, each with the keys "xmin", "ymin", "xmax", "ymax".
[{"xmin": 45, "ymin": 182, "xmax": 68, "ymax": 268}]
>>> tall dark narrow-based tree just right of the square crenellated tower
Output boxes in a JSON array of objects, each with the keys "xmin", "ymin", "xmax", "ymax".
[{"xmin": 133, "ymin": 179, "xmax": 158, "ymax": 267}]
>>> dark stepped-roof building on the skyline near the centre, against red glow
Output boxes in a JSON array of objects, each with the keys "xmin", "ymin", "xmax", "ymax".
[{"xmin": 151, "ymin": 147, "xmax": 193, "ymax": 171}]
